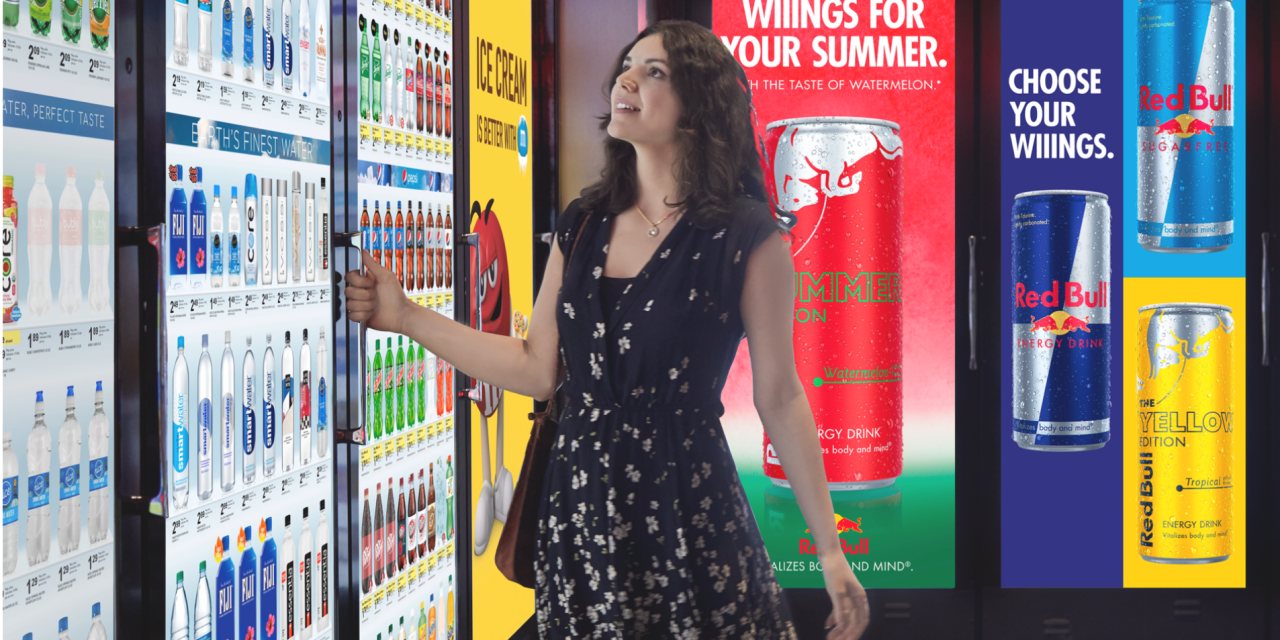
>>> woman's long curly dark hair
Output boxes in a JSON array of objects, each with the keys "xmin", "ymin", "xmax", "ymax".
[{"xmin": 580, "ymin": 20, "xmax": 768, "ymax": 227}]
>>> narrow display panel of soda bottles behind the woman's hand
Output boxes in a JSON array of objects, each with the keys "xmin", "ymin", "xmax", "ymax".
[{"xmin": 348, "ymin": 0, "xmax": 460, "ymax": 639}]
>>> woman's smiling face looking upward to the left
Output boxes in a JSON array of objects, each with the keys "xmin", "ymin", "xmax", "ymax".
[{"xmin": 608, "ymin": 35, "xmax": 681, "ymax": 146}]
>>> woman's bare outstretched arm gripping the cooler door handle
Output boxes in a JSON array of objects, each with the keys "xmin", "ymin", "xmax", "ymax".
[{"xmin": 347, "ymin": 239, "xmax": 564, "ymax": 401}]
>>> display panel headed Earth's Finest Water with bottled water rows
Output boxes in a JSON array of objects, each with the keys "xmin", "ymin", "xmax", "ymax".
[{"xmin": 161, "ymin": 5, "xmax": 338, "ymax": 639}]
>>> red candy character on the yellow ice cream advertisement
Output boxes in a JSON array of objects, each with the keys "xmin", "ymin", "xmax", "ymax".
[{"xmin": 467, "ymin": 200, "xmax": 515, "ymax": 556}]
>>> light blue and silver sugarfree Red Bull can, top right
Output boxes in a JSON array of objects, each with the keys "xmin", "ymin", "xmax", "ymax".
[{"xmin": 1138, "ymin": 0, "xmax": 1235, "ymax": 253}]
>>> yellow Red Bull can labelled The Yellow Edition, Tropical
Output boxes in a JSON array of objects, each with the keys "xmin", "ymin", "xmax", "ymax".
[{"xmin": 1134, "ymin": 302, "xmax": 1235, "ymax": 564}]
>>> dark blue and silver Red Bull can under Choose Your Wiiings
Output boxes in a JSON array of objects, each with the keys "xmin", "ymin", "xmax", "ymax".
[{"xmin": 1012, "ymin": 191, "xmax": 1111, "ymax": 451}]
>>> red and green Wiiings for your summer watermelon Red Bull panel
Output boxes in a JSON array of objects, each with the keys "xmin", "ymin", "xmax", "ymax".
[{"xmin": 713, "ymin": 0, "xmax": 956, "ymax": 588}]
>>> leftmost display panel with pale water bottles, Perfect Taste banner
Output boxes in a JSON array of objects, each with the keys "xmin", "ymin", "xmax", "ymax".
[{"xmin": 0, "ymin": 0, "xmax": 115, "ymax": 640}]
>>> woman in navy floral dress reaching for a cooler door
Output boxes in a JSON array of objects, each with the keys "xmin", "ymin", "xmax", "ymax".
[{"xmin": 347, "ymin": 22, "xmax": 869, "ymax": 639}]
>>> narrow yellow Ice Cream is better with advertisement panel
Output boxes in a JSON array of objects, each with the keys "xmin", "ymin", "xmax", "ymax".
[{"xmin": 465, "ymin": 0, "xmax": 534, "ymax": 637}]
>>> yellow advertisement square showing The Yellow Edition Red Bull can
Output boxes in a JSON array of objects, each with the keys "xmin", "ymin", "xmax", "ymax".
[{"xmin": 1124, "ymin": 278, "xmax": 1247, "ymax": 589}]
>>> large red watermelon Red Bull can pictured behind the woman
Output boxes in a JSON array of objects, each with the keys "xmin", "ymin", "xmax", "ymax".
[{"xmin": 764, "ymin": 118, "xmax": 902, "ymax": 492}]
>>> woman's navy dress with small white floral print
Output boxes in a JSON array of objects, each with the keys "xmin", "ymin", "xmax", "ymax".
[{"xmin": 535, "ymin": 198, "xmax": 795, "ymax": 640}]
